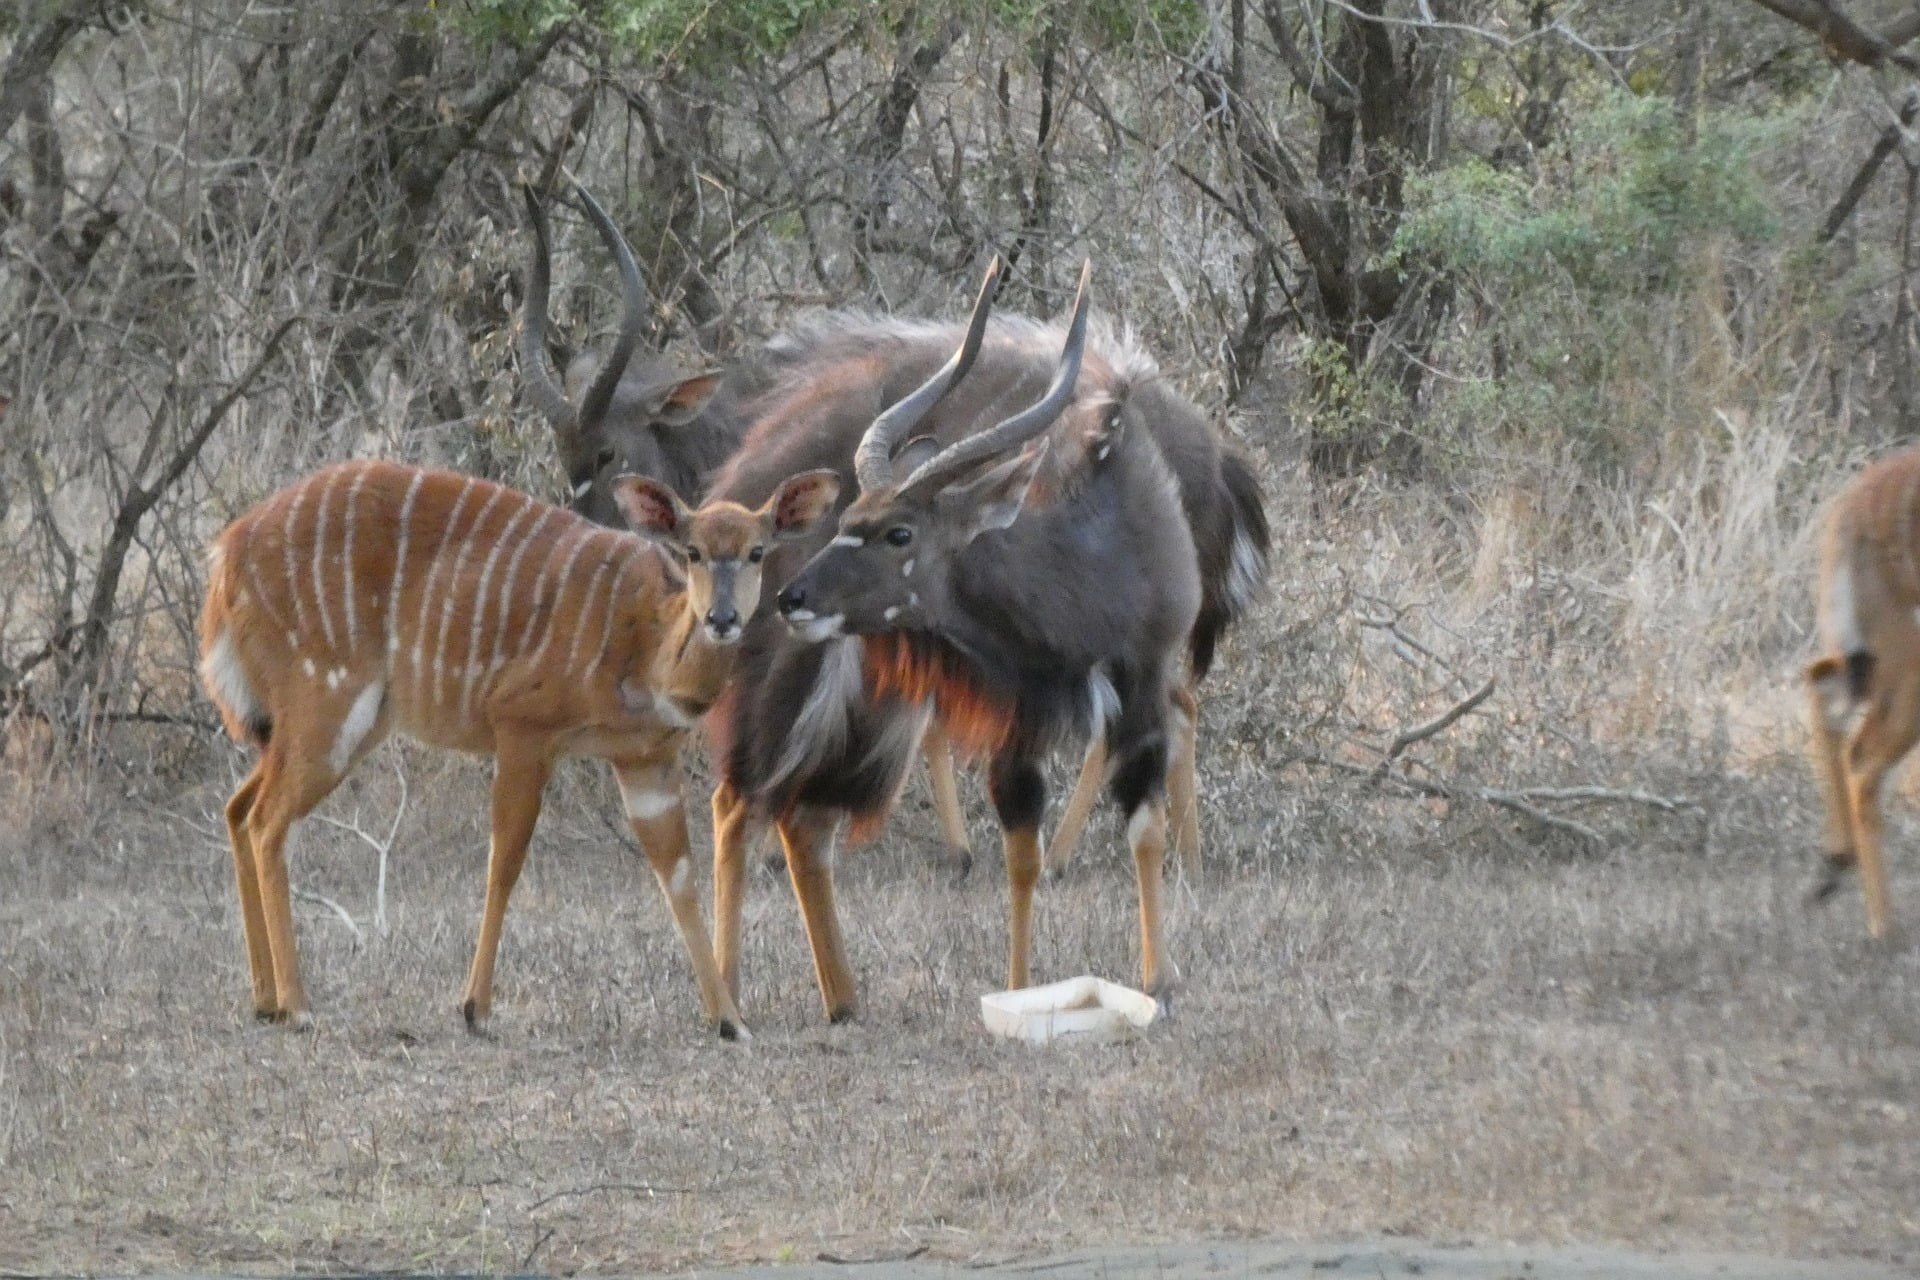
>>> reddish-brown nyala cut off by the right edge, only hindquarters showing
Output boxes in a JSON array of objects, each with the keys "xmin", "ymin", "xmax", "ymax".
[{"xmin": 1807, "ymin": 449, "xmax": 1920, "ymax": 938}]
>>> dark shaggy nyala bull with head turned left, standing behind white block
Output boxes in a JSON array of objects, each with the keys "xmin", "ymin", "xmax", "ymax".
[{"xmin": 710, "ymin": 260, "xmax": 1263, "ymax": 1021}]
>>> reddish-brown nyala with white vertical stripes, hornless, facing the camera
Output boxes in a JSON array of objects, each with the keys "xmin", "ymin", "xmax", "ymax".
[{"xmin": 200, "ymin": 461, "xmax": 839, "ymax": 1036}]
